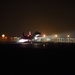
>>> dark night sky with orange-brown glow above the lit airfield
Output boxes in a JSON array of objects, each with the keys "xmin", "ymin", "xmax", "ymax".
[{"xmin": 0, "ymin": 0, "xmax": 75, "ymax": 36}]
